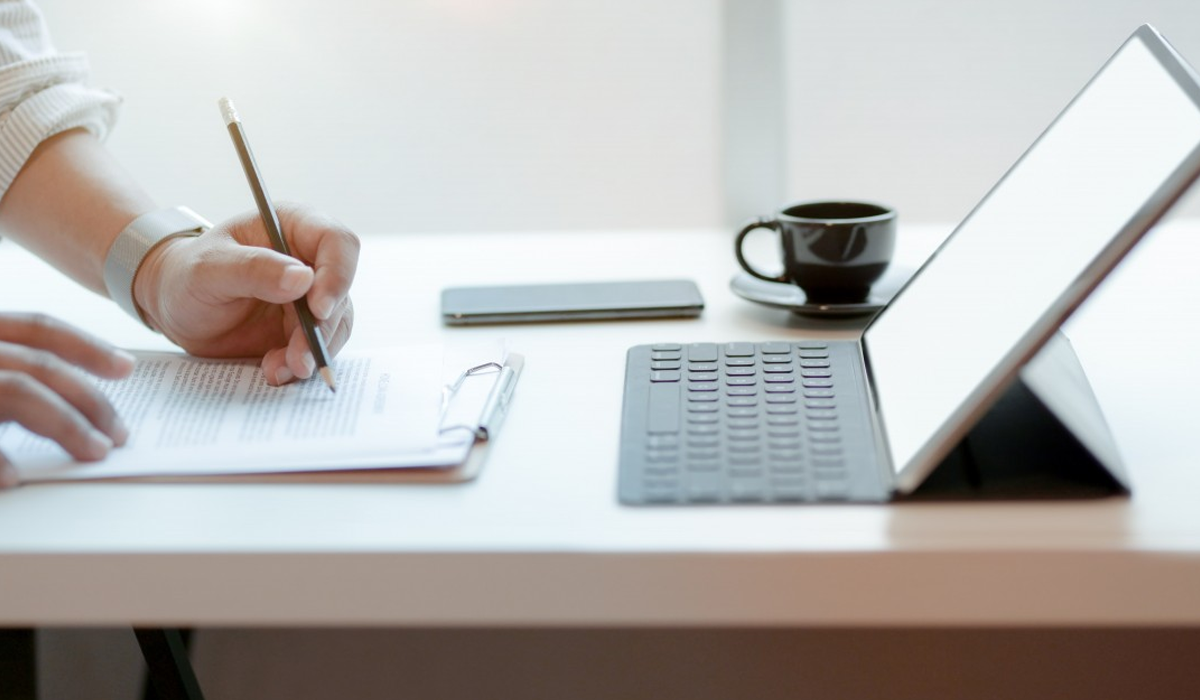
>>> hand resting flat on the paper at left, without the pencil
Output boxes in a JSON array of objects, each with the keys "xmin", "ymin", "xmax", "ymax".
[{"xmin": 0, "ymin": 313, "xmax": 133, "ymax": 487}]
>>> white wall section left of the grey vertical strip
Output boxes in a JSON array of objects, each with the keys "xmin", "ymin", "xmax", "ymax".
[{"xmin": 41, "ymin": 0, "xmax": 721, "ymax": 232}]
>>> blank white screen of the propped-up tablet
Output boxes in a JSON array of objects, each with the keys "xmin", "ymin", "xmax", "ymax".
[{"xmin": 864, "ymin": 37, "xmax": 1200, "ymax": 482}]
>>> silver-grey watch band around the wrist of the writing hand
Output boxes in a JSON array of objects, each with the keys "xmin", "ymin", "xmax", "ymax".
[{"xmin": 104, "ymin": 207, "xmax": 212, "ymax": 328}]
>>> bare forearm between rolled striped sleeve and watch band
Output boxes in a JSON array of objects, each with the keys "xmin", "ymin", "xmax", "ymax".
[{"xmin": 0, "ymin": 128, "xmax": 156, "ymax": 295}]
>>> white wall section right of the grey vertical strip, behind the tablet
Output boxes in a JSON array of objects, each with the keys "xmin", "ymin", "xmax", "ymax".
[{"xmin": 785, "ymin": 0, "xmax": 1200, "ymax": 221}]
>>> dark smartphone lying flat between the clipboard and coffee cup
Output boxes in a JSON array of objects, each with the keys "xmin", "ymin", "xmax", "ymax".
[{"xmin": 442, "ymin": 280, "xmax": 704, "ymax": 325}]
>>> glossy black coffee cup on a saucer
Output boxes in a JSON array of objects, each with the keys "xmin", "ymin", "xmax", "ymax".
[{"xmin": 734, "ymin": 202, "xmax": 896, "ymax": 304}]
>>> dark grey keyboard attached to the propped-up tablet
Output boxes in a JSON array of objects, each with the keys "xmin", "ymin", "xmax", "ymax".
[{"xmin": 619, "ymin": 341, "xmax": 878, "ymax": 504}]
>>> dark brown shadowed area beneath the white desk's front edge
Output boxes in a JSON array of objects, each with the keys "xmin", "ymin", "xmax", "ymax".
[{"xmin": 38, "ymin": 629, "xmax": 1200, "ymax": 700}]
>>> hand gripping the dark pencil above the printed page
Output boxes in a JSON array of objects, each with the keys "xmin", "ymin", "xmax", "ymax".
[{"xmin": 133, "ymin": 205, "xmax": 359, "ymax": 384}]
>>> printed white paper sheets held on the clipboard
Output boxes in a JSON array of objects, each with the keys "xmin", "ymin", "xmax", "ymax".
[{"xmin": 0, "ymin": 346, "xmax": 505, "ymax": 481}]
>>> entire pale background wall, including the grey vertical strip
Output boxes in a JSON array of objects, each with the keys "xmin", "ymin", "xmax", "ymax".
[{"xmin": 32, "ymin": 0, "xmax": 1200, "ymax": 232}]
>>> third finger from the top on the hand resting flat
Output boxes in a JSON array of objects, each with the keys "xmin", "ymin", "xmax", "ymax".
[{"xmin": 0, "ymin": 370, "xmax": 113, "ymax": 461}]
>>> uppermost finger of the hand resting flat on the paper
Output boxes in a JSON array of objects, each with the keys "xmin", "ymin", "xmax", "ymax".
[{"xmin": 0, "ymin": 313, "xmax": 134, "ymax": 379}]
